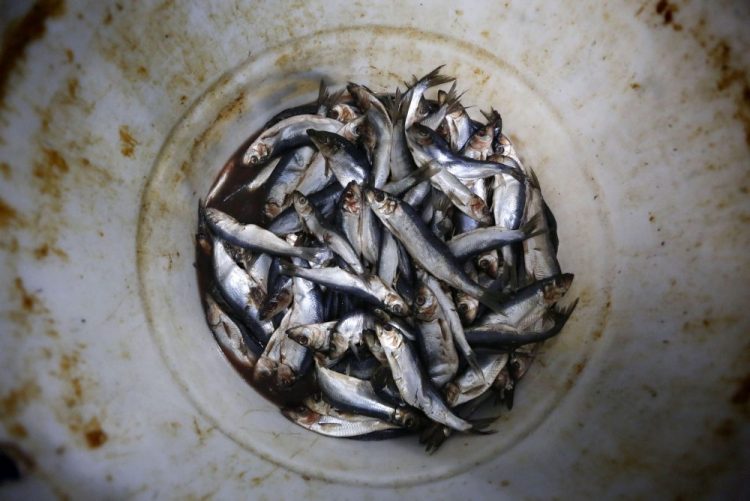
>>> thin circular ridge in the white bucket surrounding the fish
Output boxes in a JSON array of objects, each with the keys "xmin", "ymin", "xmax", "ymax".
[{"xmin": 137, "ymin": 25, "xmax": 614, "ymax": 486}]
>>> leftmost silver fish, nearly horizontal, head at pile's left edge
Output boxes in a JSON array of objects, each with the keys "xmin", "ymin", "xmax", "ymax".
[{"xmin": 205, "ymin": 207, "xmax": 331, "ymax": 263}]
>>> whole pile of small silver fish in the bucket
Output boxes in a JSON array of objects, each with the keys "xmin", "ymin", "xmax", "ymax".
[{"xmin": 198, "ymin": 67, "xmax": 577, "ymax": 451}]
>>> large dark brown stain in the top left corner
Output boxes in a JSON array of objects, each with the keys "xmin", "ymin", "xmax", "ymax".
[{"xmin": 0, "ymin": 0, "xmax": 65, "ymax": 106}]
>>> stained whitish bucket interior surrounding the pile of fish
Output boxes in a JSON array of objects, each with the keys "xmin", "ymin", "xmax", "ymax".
[{"xmin": 0, "ymin": 0, "xmax": 750, "ymax": 499}]
